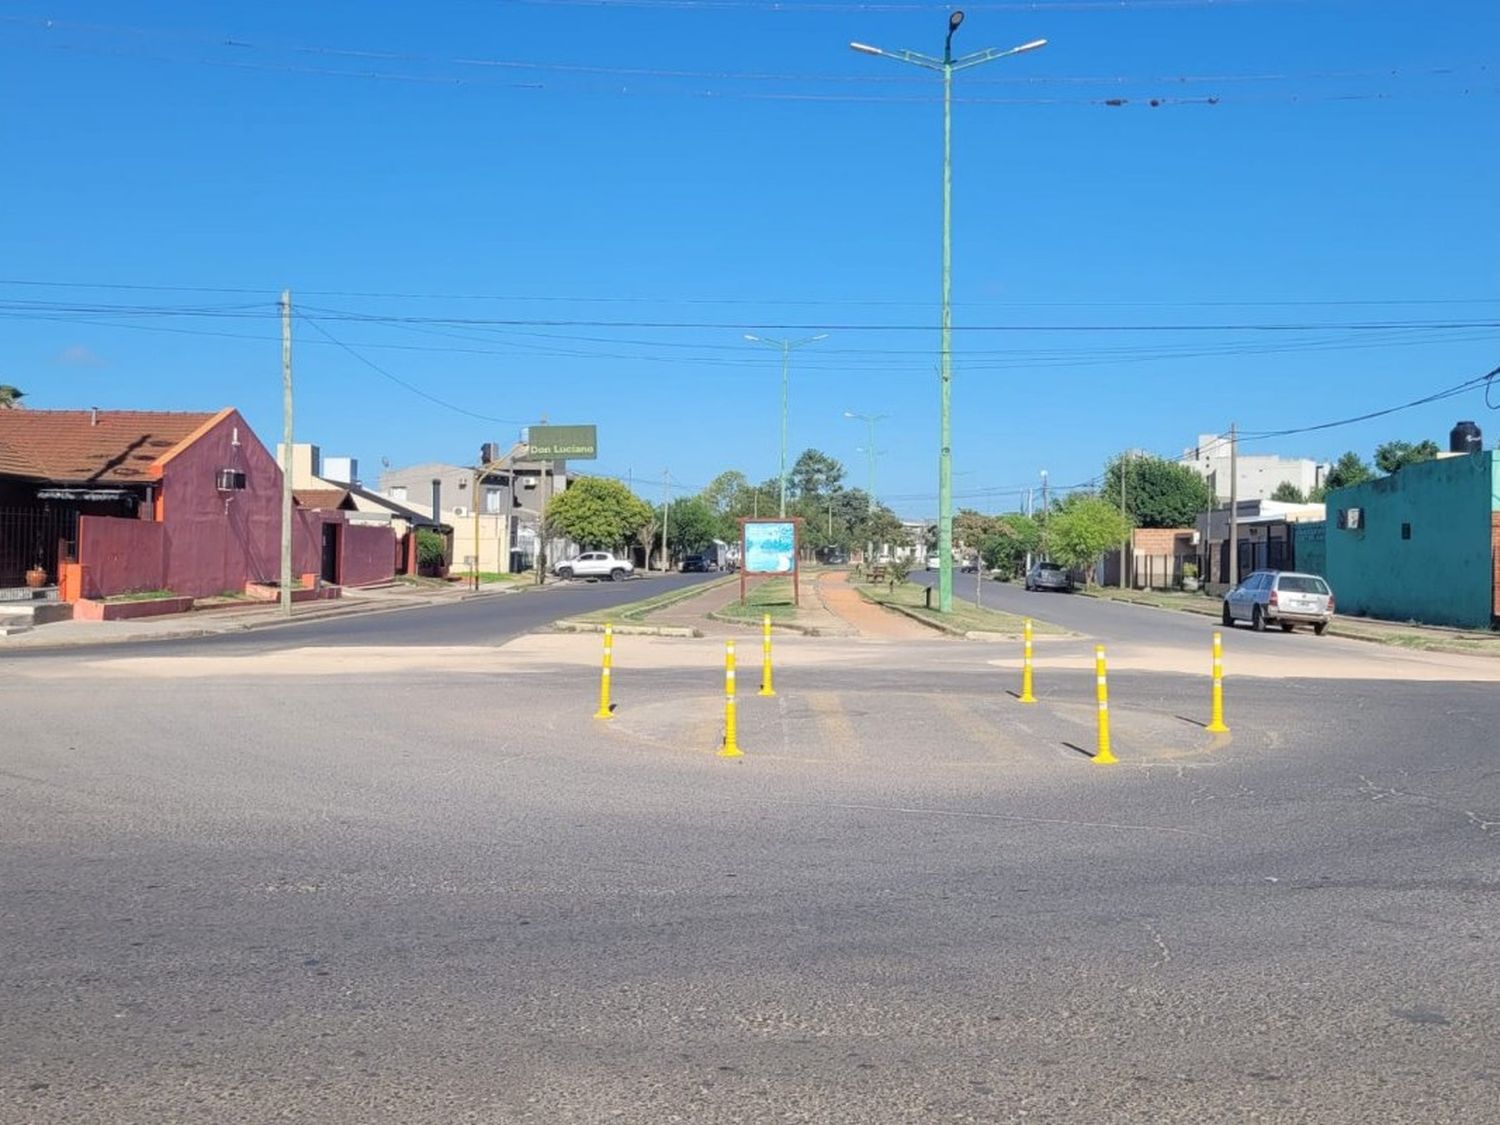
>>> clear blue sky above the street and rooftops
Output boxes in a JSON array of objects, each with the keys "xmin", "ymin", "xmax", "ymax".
[{"xmin": 0, "ymin": 0, "xmax": 1500, "ymax": 516}]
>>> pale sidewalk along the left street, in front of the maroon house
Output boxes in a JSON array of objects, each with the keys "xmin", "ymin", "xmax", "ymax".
[{"xmin": 0, "ymin": 582, "xmax": 534, "ymax": 656}]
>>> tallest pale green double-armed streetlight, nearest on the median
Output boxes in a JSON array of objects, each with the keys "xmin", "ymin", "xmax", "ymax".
[{"xmin": 849, "ymin": 12, "xmax": 1047, "ymax": 614}]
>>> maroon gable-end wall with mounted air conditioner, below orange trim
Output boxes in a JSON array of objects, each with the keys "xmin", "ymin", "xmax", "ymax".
[{"xmin": 155, "ymin": 410, "xmax": 323, "ymax": 597}]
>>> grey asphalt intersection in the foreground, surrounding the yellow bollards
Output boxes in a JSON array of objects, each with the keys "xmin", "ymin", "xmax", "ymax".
[{"xmin": 0, "ymin": 630, "xmax": 1500, "ymax": 1125}]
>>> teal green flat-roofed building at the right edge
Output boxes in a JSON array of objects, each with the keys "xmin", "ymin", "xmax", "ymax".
[{"xmin": 1323, "ymin": 452, "xmax": 1500, "ymax": 629}]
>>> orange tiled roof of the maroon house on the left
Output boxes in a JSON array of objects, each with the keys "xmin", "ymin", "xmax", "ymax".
[{"xmin": 0, "ymin": 410, "xmax": 216, "ymax": 483}]
